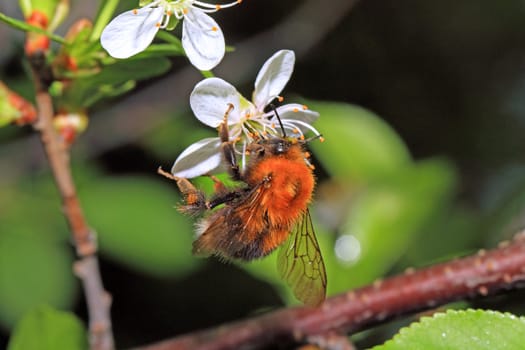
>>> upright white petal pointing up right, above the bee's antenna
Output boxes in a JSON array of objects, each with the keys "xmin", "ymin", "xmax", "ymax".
[{"xmin": 253, "ymin": 50, "xmax": 295, "ymax": 110}]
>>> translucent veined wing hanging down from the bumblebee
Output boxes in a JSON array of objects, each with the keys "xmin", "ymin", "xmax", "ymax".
[{"xmin": 277, "ymin": 209, "xmax": 326, "ymax": 306}]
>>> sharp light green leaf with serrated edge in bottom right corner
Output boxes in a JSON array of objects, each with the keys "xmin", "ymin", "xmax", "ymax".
[{"xmin": 373, "ymin": 310, "xmax": 525, "ymax": 350}]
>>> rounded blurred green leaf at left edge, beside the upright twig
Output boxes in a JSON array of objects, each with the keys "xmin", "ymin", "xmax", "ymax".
[{"xmin": 0, "ymin": 228, "xmax": 76, "ymax": 327}]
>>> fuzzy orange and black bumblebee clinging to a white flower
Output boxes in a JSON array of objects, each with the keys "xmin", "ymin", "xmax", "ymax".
[{"xmin": 159, "ymin": 106, "xmax": 326, "ymax": 306}]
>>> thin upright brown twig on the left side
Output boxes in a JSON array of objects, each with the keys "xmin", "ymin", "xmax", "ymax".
[{"xmin": 30, "ymin": 57, "xmax": 114, "ymax": 350}]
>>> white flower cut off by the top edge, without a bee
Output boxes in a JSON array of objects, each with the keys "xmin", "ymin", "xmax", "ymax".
[{"xmin": 100, "ymin": 0, "xmax": 242, "ymax": 70}]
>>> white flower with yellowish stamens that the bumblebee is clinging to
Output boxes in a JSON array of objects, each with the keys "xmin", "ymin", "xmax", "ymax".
[{"xmin": 171, "ymin": 50, "xmax": 320, "ymax": 178}]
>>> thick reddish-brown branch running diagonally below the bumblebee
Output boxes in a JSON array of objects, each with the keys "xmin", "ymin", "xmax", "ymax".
[{"xmin": 136, "ymin": 232, "xmax": 525, "ymax": 350}]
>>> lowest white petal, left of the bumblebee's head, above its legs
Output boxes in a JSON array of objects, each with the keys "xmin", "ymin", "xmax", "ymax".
[{"xmin": 171, "ymin": 137, "xmax": 222, "ymax": 179}]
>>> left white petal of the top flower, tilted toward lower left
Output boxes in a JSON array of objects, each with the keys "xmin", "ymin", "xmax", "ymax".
[{"xmin": 100, "ymin": 7, "xmax": 164, "ymax": 58}]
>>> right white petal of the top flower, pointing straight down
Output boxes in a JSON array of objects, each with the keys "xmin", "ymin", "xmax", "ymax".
[{"xmin": 182, "ymin": 8, "xmax": 225, "ymax": 70}]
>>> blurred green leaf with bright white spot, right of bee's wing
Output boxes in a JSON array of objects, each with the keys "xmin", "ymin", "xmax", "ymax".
[{"xmin": 325, "ymin": 160, "xmax": 456, "ymax": 293}]
